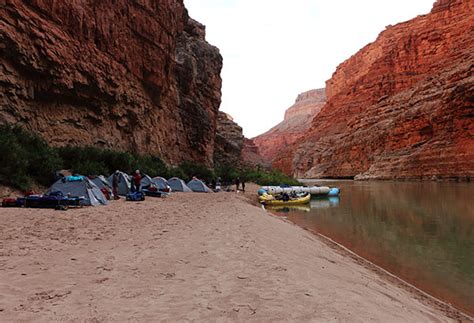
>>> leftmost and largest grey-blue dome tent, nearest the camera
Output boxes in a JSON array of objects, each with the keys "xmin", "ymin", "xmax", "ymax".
[{"xmin": 46, "ymin": 176, "xmax": 108, "ymax": 206}]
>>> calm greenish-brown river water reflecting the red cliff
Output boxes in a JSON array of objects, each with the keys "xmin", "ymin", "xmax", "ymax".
[{"xmin": 264, "ymin": 181, "xmax": 474, "ymax": 315}]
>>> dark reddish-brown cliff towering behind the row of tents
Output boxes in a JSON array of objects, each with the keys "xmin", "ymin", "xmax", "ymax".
[{"xmin": 0, "ymin": 0, "xmax": 222, "ymax": 165}]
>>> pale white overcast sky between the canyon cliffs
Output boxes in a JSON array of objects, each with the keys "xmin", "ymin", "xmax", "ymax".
[{"xmin": 184, "ymin": 0, "xmax": 434, "ymax": 138}]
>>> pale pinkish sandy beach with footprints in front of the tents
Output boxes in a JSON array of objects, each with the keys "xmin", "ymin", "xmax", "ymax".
[{"xmin": 0, "ymin": 187, "xmax": 468, "ymax": 322}]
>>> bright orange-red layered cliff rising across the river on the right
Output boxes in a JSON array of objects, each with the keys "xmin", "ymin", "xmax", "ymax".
[{"xmin": 273, "ymin": 0, "xmax": 474, "ymax": 179}]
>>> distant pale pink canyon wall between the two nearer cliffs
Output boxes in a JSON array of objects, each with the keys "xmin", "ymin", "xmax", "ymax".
[{"xmin": 252, "ymin": 89, "xmax": 326, "ymax": 163}]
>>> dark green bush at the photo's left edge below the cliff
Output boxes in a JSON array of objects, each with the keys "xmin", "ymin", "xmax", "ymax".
[{"xmin": 0, "ymin": 125, "xmax": 61, "ymax": 190}]
